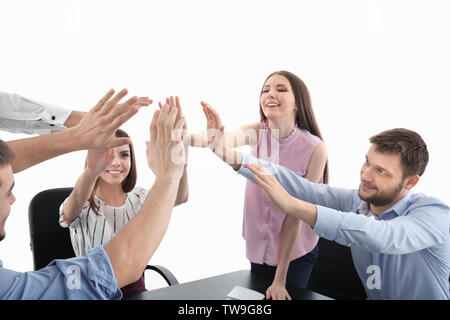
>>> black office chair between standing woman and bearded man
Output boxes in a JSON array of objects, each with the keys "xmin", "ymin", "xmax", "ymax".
[{"xmin": 307, "ymin": 238, "xmax": 367, "ymax": 300}]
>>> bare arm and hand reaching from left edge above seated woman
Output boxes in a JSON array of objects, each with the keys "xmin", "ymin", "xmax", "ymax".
[{"xmin": 7, "ymin": 89, "xmax": 151, "ymax": 173}]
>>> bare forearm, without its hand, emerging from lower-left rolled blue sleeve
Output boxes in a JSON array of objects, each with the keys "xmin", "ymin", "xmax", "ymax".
[{"xmin": 105, "ymin": 176, "xmax": 179, "ymax": 287}]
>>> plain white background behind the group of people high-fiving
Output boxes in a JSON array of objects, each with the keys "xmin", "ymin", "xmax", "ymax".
[{"xmin": 0, "ymin": 0, "xmax": 450, "ymax": 288}]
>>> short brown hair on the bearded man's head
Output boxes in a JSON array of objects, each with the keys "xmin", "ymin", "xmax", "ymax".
[{"xmin": 369, "ymin": 128, "xmax": 428, "ymax": 178}]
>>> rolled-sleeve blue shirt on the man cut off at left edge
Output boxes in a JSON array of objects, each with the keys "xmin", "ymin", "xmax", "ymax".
[{"xmin": 0, "ymin": 246, "xmax": 122, "ymax": 300}]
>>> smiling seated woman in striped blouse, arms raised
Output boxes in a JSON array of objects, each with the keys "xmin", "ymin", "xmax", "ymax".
[{"xmin": 59, "ymin": 129, "xmax": 188, "ymax": 296}]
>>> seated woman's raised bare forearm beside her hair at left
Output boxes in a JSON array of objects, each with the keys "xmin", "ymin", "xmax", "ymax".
[{"xmin": 63, "ymin": 168, "xmax": 98, "ymax": 224}]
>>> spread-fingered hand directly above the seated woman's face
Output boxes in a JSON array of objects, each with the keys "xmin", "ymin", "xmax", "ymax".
[{"xmin": 70, "ymin": 89, "xmax": 153, "ymax": 149}]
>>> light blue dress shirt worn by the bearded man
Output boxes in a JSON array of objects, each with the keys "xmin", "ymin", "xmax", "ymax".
[{"xmin": 238, "ymin": 155, "xmax": 450, "ymax": 300}]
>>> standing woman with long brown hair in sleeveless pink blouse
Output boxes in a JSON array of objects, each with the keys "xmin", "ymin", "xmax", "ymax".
[{"xmin": 188, "ymin": 71, "xmax": 328, "ymax": 299}]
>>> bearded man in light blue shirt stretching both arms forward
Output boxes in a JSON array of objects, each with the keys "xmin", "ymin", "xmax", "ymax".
[{"xmin": 205, "ymin": 110, "xmax": 450, "ymax": 300}]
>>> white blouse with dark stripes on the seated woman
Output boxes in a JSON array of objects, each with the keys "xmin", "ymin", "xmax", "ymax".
[{"xmin": 59, "ymin": 187, "xmax": 148, "ymax": 257}]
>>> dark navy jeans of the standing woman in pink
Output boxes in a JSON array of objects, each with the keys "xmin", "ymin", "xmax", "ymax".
[{"xmin": 250, "ymin": 245, "xmax": 319, "ymax": 288}]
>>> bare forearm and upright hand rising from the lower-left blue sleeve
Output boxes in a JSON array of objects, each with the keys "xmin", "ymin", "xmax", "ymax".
[{"xmin": 105, "ymin": 105, "xmax": 185, "ymax": 287}]
